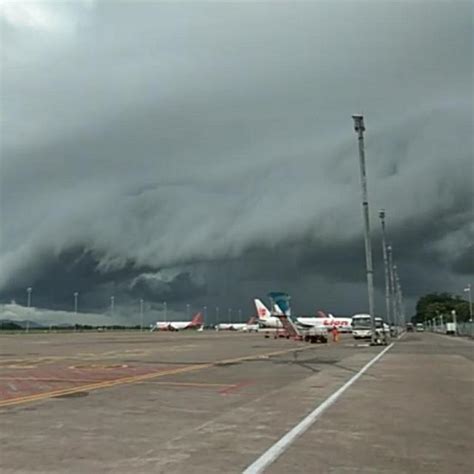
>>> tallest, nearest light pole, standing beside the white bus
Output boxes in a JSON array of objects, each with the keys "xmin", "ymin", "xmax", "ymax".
[{"xmin": 352, "ymin": 115, "xmax": 377, "ymax": 344}]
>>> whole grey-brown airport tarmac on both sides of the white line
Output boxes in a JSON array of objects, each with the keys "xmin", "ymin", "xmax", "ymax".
[{"xmin": 0, "ymin": 331, "xmax": 474, "ymax": 473}]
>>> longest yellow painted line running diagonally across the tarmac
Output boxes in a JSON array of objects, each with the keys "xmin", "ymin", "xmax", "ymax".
[{"xmin": 0, "ymin": 345, "xmax": 314, "ymax": 408}]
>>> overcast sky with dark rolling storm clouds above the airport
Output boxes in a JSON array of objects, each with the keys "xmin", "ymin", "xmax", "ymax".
[{"xmin": 0, "ymin": 0, "xmax": 474, "ymax": 317}]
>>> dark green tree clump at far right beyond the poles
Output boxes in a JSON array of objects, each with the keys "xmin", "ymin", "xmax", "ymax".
[{"xmin": 411, "ymin": 293, "xmax": 470, "ymax": 323}]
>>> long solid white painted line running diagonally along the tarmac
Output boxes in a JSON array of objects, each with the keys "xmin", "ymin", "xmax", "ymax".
[{"xmin": 242, "ymin": 342, "xmax": 394, "ymax": 474}]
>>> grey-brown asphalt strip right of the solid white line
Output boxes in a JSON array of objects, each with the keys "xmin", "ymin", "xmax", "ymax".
[{"xmin": 267, "ymin": 333, "xmax": 474, "ymax": 474}]
